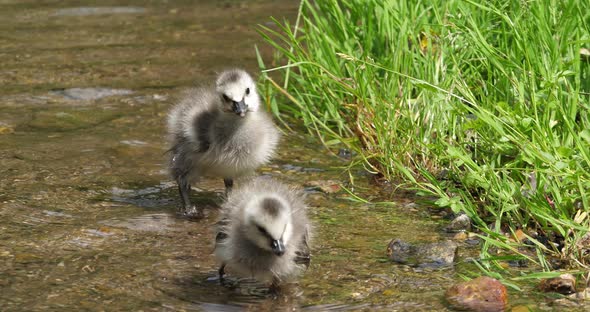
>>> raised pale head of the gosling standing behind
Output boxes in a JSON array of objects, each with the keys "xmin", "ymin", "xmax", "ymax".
[{"xmin": 216, "ymin": 69, "xmax": 260, "ymax": 117}]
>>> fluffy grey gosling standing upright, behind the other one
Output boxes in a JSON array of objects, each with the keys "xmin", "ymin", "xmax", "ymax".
[{"xmin": 168, "ymin": 69, "xmax": 279, "ymax": 218}]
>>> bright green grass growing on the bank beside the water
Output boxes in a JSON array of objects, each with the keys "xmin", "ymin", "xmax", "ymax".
[{"xmin": 260, "ymin": 0, "xmax": 590, "ymax": 282}]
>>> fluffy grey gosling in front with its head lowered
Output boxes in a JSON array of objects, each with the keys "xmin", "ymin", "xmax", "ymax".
[{"xmin": 215, "ymin": 177, "xmax": 311, "ymax": 290}]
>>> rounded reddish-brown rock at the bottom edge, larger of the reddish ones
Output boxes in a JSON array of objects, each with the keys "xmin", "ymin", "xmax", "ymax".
[{"xmin": 445, "ymin": 276, "xmax": 508, "ymax": 312}]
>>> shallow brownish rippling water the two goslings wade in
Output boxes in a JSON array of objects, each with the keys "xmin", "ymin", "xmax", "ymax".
[{"xmin": 0, "ymin": 0, "xmax": 588, "ymax": 311}]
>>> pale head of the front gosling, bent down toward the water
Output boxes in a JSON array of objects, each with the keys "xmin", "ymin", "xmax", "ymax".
[{"xmin": 244, "ymin": 196, "xmax": 293, "ymax": 256}]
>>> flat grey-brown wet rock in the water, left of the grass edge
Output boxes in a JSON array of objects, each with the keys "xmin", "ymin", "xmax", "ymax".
[{"xmin": 387, "ymin": 239, "xmax": 457, "ymax": 267}]
